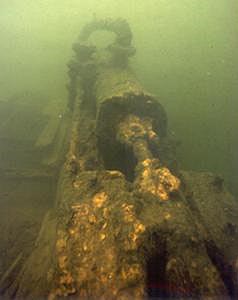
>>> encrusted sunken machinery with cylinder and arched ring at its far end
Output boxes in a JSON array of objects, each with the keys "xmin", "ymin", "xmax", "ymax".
[{"xmin": 0, "ymin": 19, "xmax": 238, "ymax": 300}]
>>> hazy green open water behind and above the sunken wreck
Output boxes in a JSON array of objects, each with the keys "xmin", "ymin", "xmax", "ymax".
[{"xmin": 0, "ymin": 0, "xmax": 238, "ymax": 193}]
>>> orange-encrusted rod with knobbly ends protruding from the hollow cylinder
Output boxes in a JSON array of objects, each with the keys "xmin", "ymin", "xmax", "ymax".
[{"xmin": 117, "ymin": 115, "xmax": 180, "ymax": 200}]
